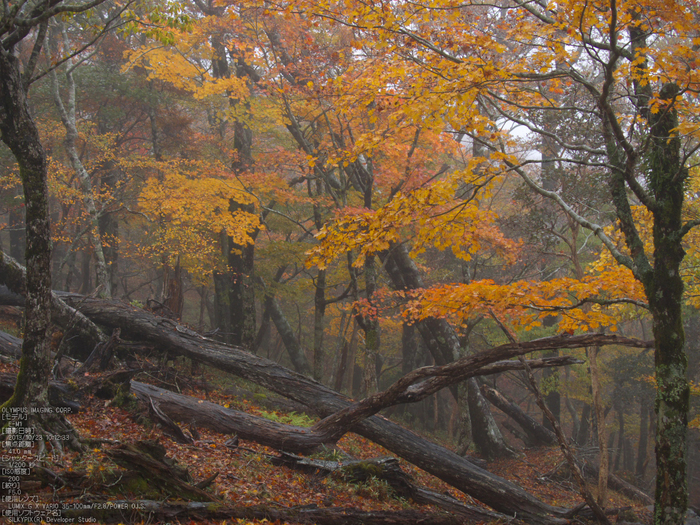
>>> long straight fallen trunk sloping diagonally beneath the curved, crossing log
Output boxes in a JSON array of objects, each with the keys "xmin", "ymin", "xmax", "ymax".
[{"xmin": 62, "ymin": 294, "xmax": 565, "ymax": 524}]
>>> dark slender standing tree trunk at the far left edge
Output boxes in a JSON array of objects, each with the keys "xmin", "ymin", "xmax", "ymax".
[{"xmin": 0, "ymin": 48, "xmax": 77, "ymax": 446}]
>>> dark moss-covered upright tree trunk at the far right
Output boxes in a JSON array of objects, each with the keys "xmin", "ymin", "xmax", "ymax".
[{"xmin": 643, "ymin": 84, "xmax": 690, "ymax": 525}]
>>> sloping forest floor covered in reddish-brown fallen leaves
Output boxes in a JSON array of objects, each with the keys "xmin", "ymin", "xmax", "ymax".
[{"xmin": 0, "ymin": 356, "xmax": 651, "ymax": 525}]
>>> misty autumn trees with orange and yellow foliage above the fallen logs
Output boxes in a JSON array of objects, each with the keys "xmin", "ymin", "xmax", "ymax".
[{"xmin": 0, "ymin": 0, "xmax": 700, "ymax": 524}]
